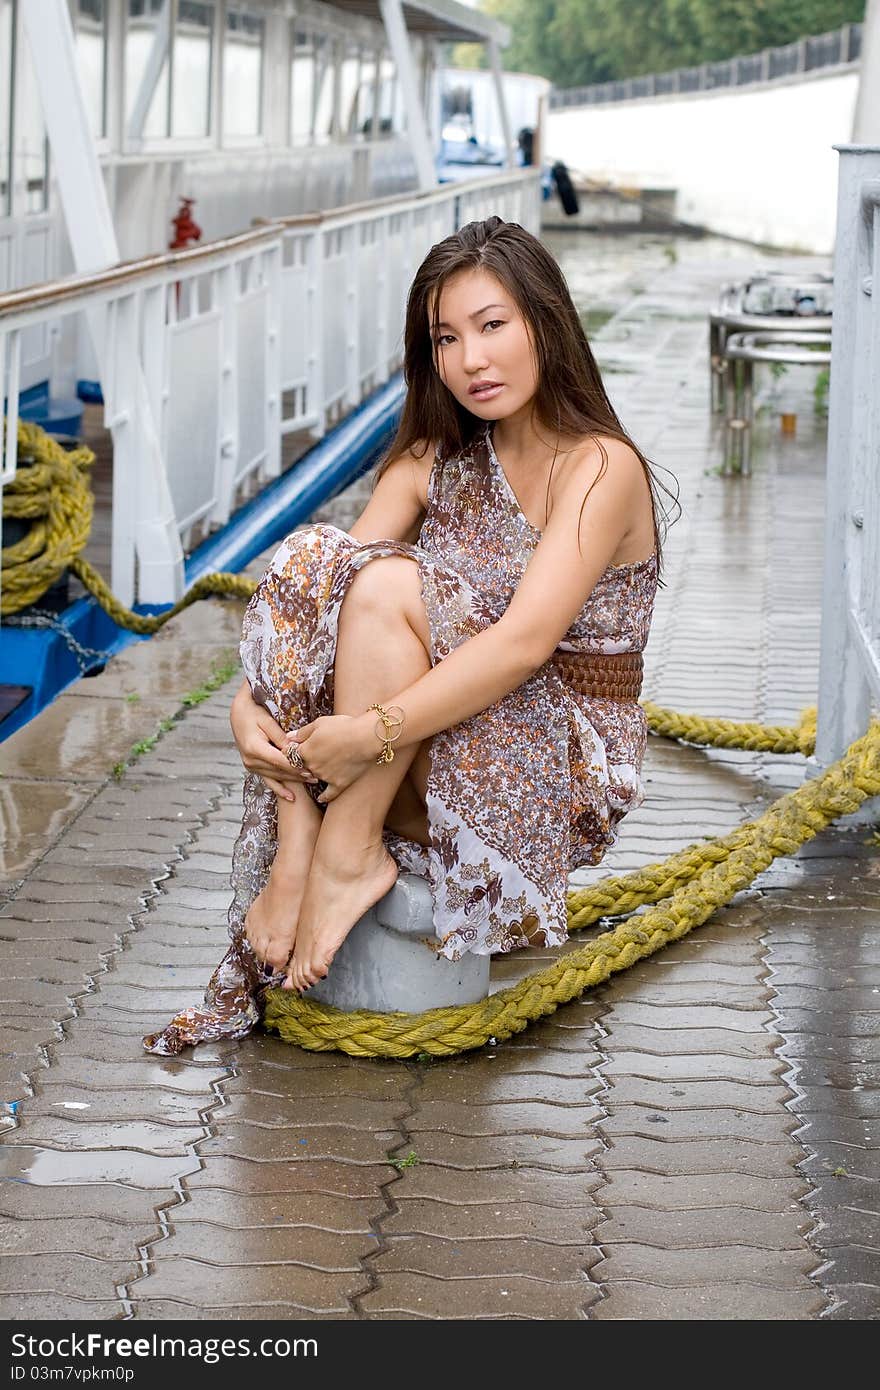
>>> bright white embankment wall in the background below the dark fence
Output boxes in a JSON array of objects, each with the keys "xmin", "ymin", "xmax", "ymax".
[{"xmin": 546, "ymin": 70, "xmax": 858, "ymax": 256}]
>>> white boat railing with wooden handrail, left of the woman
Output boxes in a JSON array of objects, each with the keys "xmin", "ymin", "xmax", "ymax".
[{"xmin": 0, "ymin": 170, "xmax": 541, "ymax": 603}]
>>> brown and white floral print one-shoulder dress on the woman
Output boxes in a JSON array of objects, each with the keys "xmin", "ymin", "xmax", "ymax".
[{"xmin": 145, "ymin": 423, "xmax": 658, "ymax": 1055}]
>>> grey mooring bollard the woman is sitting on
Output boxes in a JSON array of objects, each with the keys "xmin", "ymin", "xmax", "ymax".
[{"xmin": 306, "ymin": 873, "xmax": 489, "ymax": 1013}]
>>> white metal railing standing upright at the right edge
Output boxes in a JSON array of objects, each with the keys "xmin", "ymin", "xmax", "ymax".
[{"xmin": 816, "ymin": 145, "xmax": 880, "ymax": 765}]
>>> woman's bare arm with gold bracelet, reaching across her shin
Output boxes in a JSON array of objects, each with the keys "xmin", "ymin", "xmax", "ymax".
[{"xmin": 293, "ymin": 441, "xmax": 651, "ymax": 799}]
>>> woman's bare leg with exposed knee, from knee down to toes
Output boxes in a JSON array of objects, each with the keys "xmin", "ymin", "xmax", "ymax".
[{"xmin": 285, "ymin": 557, "xmax": 431, "ymax": 990}]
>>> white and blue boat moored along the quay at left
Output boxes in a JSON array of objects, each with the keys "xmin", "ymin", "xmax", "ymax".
[{"xmin": 0, "ymin": 0, "xmax": 546, "ymax": 739}]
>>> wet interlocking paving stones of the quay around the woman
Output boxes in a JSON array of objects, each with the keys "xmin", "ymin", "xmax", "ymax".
[{"xmin": 0, "ymin": 250, "xmax": 880, "ymax": 1321}]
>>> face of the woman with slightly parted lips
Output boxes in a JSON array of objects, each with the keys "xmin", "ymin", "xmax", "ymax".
[{"xmin": 428, "ymin": 270, "xmax": 538, "ymax": 420}]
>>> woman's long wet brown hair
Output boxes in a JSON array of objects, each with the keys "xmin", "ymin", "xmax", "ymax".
[{"xmin": 377, "ymin": 217, "xmax": 681, "ymax": 574}]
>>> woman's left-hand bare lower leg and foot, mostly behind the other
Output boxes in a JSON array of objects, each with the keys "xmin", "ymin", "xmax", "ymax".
[{"xmin": 245, "ymin": 787, "xmax": 321, "ymax": 970}]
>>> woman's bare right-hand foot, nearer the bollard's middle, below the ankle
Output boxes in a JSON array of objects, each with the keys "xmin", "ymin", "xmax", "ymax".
[{"xmin": 282, "ymin": 841, "xmax": 398, "ymax": 991}]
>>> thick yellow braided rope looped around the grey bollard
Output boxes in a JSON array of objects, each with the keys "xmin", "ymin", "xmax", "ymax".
[{"xmin": 264, "ymin": 713, "xmax": 880, "ymax": 1058}]
